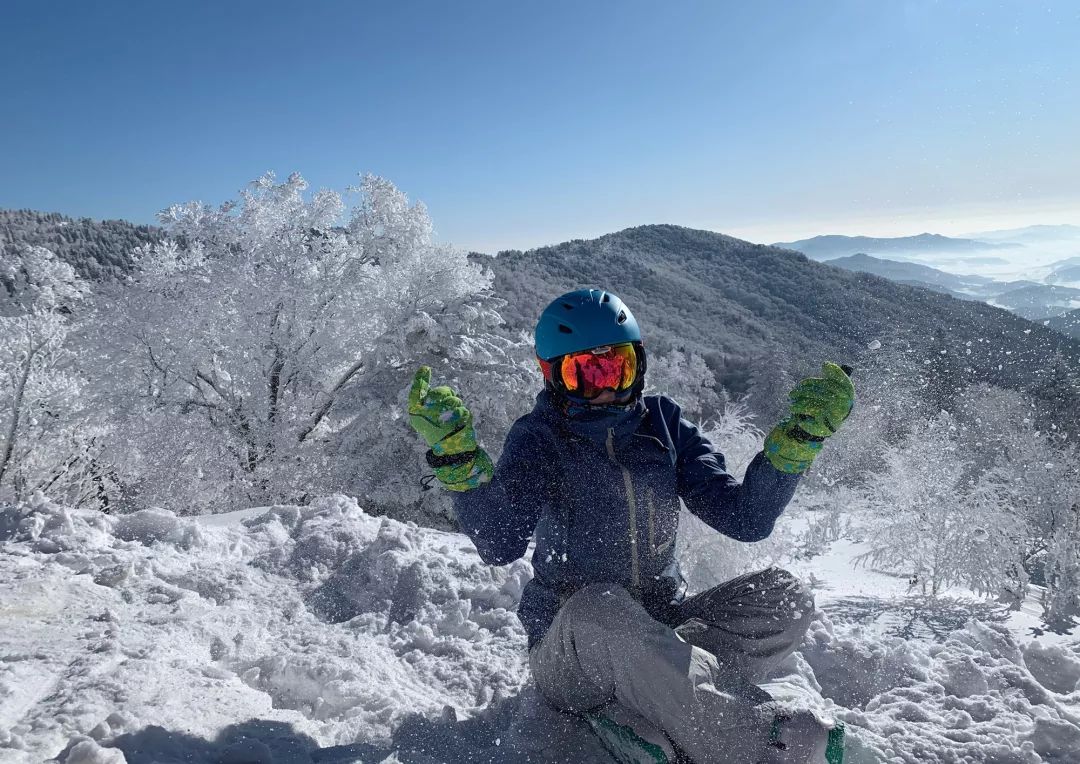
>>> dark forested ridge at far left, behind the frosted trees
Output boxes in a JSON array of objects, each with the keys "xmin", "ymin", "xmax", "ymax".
[{"xmin": 0, "ymin": 210, "xmax": 161, "ymax": 280}]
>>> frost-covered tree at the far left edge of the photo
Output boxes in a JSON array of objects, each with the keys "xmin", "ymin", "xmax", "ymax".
[{"xmin": 0, "ymin": 246, "xmax": 111, "ymax": 507}]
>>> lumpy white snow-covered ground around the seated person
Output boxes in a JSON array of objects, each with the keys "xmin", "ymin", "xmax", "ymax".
[{"xmin": 0, "ymin": 497, "xmax": 1080, "ymax": 764}]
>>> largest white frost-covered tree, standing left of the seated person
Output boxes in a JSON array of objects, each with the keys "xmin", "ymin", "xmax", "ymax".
[{"xmin": 102, "ymin": 174, "xmax": 520, "ymax": 520}]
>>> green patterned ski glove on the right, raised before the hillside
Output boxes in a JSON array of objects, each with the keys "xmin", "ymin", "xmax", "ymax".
[{"xmin": 765, "ymin": 362, "xmax": 855, "ymax": 474}]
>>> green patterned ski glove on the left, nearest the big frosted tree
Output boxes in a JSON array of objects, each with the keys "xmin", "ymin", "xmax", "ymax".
[{"xmin": 408, "ymin": 366, "xmax": 495, "ymax": 491}]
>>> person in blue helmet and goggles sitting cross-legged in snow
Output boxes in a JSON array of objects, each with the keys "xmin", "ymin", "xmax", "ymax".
[{"xmin": 408, "ymin": 290, "xmax": 854, "ymax": 764}]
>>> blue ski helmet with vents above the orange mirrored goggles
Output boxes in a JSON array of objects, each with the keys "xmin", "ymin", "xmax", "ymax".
[{"xmin": 536, "ymin": 290, "xmax": 642, "ymax": 361}]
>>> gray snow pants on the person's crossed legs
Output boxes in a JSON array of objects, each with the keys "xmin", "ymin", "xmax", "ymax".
[{"xmin": 529, "ymin": 567, "xmax": 814, "ymax": 764}]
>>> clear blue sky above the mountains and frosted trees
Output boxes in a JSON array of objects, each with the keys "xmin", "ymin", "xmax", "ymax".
[{"xmin": 0, "ymin": 0, "xmax": 1080, "ymax": 251}]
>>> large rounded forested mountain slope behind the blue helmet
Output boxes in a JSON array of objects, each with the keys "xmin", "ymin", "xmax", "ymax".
[{"xmin": 480, "ymin": 225, "xmax": 1080, "ymax": 423}]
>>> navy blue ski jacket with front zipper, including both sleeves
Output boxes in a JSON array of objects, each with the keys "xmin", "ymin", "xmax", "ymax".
[{"xmin": 454, "ymin": 390, "xmax": 799, "ymax": 646}]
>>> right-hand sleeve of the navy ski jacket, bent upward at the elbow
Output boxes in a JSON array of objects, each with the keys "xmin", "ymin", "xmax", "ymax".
[{"xmin": 670, "ymin": 405, "xmax": 799, "ymax": 541}]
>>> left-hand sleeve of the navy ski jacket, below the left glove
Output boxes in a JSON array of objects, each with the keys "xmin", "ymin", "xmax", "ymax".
[{"xmin": 454, "ymin": 418, "xmax": 549, "ymax": 565}]
